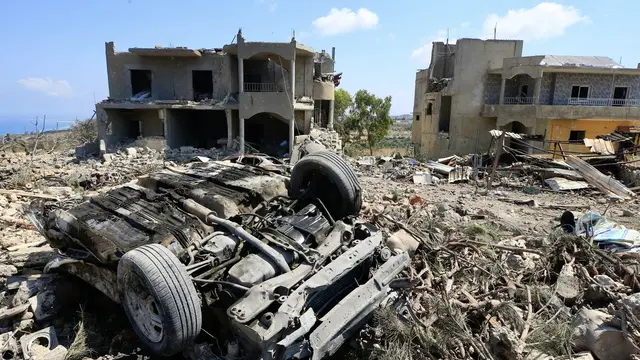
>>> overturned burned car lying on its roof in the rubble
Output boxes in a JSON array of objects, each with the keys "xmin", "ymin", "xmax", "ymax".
[{"xmin": 36, "ymin": 151, "xmax": 410, "ymax": 359}]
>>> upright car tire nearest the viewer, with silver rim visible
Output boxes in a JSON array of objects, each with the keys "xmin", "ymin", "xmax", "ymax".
[{"xmin": 118, "ymin": 244, "xmax": 202, "ymax": 356}]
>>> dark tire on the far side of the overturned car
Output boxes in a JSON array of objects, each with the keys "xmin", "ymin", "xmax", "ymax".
[{"xmin": 290, "ymin": 151, "xmax": 362, "ymax": 220}]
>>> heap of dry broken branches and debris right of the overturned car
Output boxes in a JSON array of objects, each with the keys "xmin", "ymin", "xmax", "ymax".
[{"xmin": 358, "ymin": 200, "xmax": 640, "ymax": 360}]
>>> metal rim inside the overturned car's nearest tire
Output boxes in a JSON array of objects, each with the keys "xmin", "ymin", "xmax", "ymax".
[{"xmin": 125, "ymin": 275, "xmax": 163, "ymax": 342}]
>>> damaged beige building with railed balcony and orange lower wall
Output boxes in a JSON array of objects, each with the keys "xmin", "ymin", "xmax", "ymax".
[{"xmin": 412, "ymin": 39, "xmax": 640, "ymax": 157}]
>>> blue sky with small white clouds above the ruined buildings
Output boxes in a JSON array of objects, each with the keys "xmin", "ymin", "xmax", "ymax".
[{"xmin": 0, "ymin": 0, "xmax": 640, "ymax": 134}]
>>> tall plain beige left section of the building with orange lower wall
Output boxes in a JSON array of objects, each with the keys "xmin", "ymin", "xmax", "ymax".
[{"xmin": 412, "ymin": 39, "xmax": 522, "ymax": 158}]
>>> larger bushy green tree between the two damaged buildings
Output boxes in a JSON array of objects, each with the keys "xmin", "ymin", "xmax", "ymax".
[{"xmin": 347, "ymin": 90, "xmax": 393, "ymax": 155}]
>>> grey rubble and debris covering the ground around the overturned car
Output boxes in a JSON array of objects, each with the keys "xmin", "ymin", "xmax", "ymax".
[{"xmin": 0, "ymin": 133, "xmax": 640, "ymax": 360}]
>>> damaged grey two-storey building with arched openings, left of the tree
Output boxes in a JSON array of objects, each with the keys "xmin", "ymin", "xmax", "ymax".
[{"xmin": 96, "ymin": 31, "xmax": 340, "ymax": 155}]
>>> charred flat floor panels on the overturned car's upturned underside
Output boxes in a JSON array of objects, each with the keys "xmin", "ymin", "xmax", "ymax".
[{"xmin": 51, "ymin": 162, "xmax": 286, "ymax": 263}]
